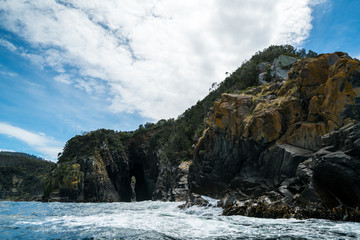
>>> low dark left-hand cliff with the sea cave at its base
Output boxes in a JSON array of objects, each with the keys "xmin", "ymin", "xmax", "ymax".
[{"xmin": 44, "ymin": 128, "xmax": 187, "ymax": 202}]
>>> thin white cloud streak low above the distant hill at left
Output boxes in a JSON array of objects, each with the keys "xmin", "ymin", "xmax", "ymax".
[{"xmin": 0, "ymin": 122, "xmax": 62, "ymax": 160}]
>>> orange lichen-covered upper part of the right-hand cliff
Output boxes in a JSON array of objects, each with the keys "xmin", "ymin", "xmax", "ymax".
[{"xmin": 204, "ymin": 52, "xmax": 360, "ymax": 150}]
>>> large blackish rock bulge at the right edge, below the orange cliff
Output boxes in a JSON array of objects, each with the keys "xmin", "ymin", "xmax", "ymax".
[{"xmin": 313, "ymin": 123, "xmax": 360, "ymax": 208}]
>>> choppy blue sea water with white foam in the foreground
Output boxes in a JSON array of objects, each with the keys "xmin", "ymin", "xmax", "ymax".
[{"xmin": 0, "ymin": 201, "xmax": 360, "ymax": 240}]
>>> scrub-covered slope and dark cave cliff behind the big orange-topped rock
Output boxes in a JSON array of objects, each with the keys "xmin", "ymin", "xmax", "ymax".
[{"xmin": 44, "ymin": 45, "xmax": 310, "ymax": 201}]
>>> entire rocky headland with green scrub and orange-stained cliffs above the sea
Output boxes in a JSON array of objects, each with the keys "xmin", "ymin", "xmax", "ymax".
[{"xmin": 44, "ymin": 46, "xmax": 360, "ymax": 221}]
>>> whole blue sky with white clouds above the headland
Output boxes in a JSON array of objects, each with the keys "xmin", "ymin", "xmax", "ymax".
[{"xmin": 0, "ymin": 0, "xmax": 360, "ymax": 161}]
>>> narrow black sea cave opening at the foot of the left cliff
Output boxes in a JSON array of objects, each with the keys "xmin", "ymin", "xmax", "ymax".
[{"xmin": 129, "ymin": 162, "xmax": 151, "ymax": 201}]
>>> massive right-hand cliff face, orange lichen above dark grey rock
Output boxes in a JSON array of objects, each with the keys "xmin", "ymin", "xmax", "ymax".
[{"xmin": 189, "ymin": 52, "xmax": 360, "ymax": 220}]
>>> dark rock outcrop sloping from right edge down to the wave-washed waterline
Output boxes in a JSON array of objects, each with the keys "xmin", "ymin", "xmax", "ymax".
[{"xmin": 220, "ymin": 123, "xmax": 360, "ymax": 221}]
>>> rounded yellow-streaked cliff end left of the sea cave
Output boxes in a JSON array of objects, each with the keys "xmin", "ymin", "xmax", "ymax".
[{"xmin": 45, "ymin": 133, "xmax": 130, "ymax": 202}]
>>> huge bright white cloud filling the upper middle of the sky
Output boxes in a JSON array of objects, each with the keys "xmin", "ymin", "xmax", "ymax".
[{"xmin": 0, "ymin": 0, "xmax": 319, "ymax": 119}]
